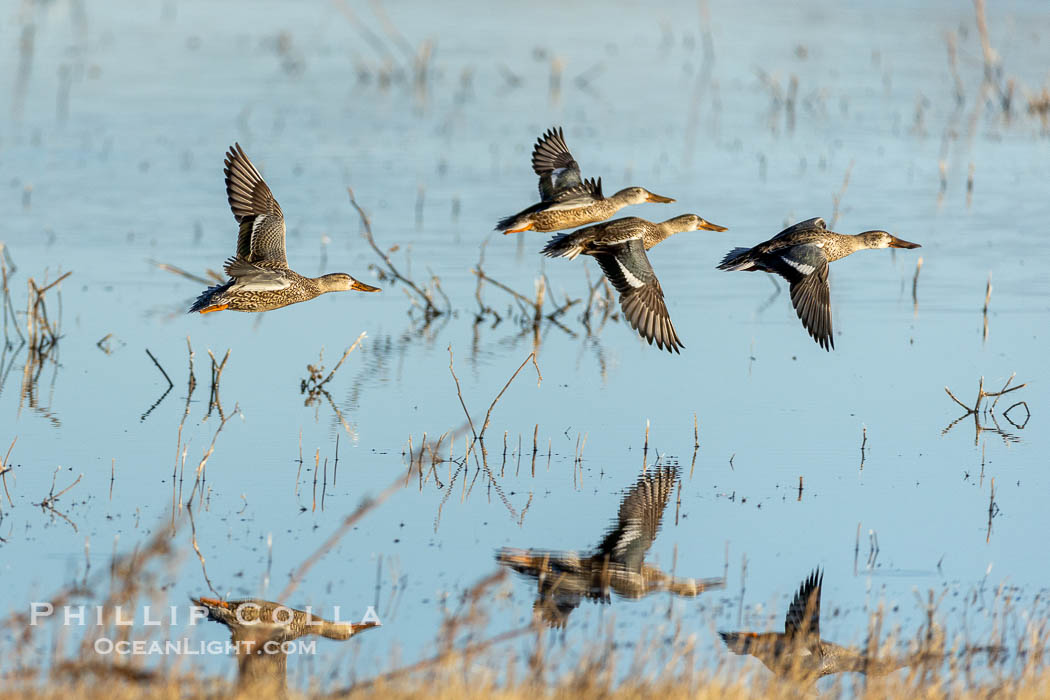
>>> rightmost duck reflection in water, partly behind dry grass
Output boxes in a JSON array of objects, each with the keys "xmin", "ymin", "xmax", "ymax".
[{"xmin": 718, "ymin": 569, "xmax": 923, "ymax": 684}]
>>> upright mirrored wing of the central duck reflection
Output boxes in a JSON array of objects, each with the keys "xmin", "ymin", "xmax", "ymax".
[{"xmin": 597, "ymin": 467, "xmax": 678, "ymax": 572}]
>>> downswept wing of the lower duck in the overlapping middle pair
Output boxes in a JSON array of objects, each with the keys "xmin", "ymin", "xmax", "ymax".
[{"xmin": 593, "ymin": 234, "xmax": 686, "ymax": 353}]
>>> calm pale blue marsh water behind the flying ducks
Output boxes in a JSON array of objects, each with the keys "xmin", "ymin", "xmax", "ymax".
[{"xmin": 0, "ymin": 1, "xmax": 1050, "ymax": 679}]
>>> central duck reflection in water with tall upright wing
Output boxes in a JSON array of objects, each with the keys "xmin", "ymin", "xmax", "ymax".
[{"xmin": 496, "ymin": 467, "xmax": 726, "ymax": 627}]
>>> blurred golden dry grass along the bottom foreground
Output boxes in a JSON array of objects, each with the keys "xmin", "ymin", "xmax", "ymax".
[{"xmin": 0, "ymin": 505, "xmax": 1050, "ymax": 700}]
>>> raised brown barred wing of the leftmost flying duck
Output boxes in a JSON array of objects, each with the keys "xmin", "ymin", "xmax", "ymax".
[{"xmin": 223, "ymin": 144, "xmax": 288, "ymax": 267}]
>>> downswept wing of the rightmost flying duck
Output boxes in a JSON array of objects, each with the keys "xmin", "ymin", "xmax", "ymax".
[{"xmin": 762, "ymin": 243, "xmax": 835, "ymax": 351}]
